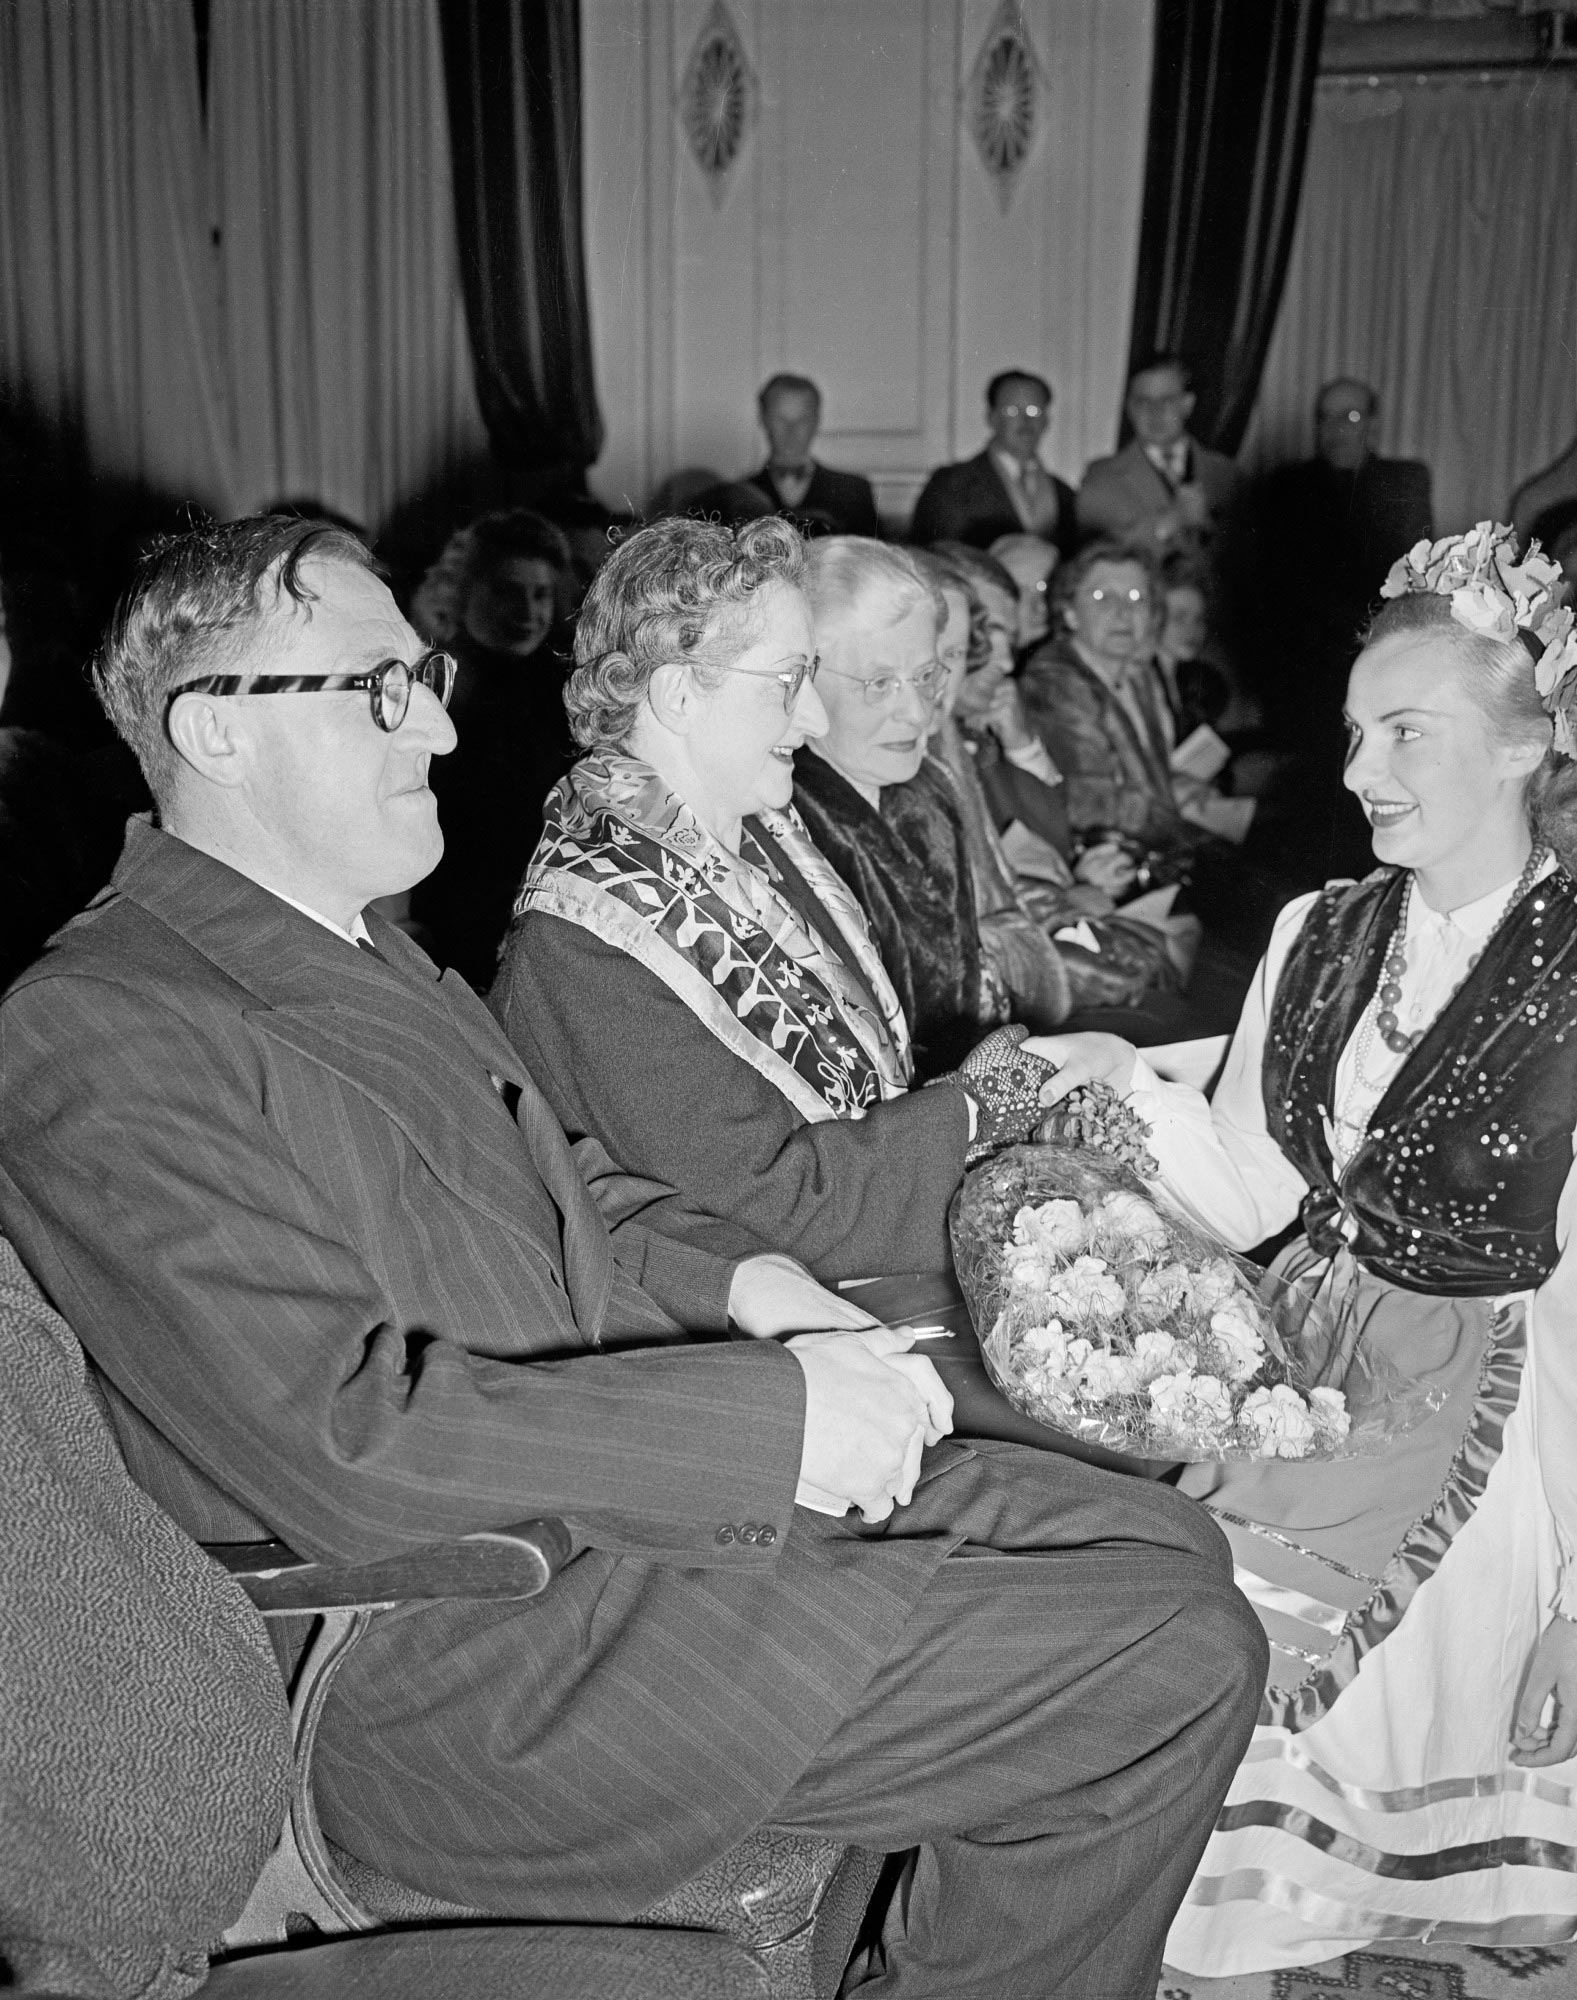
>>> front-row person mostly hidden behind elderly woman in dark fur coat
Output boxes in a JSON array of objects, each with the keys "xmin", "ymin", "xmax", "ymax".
[{"xmin": 913, "ymin": 550, "xmax": 1185, "ymax": 1042}]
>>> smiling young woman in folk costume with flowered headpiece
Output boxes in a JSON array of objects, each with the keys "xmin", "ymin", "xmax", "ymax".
[{"xmin": 1047, "ymin": 522, "xmax": 1577, "ymax": 1976}]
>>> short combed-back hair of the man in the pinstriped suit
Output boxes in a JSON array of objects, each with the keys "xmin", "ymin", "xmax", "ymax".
[{"xmin": 92, "ymin": 514, "xmax": 376, "ymax": 806}]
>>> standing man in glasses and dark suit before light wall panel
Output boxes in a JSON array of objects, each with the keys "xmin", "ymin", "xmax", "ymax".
[{"xmin": 909, "ymin": 368, "xmax": 1079, "ymax": 556}]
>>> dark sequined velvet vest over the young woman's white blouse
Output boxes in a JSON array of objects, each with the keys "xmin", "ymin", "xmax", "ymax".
[{"xmin": 1263, "ymin": 868, "xmax": 1577, "ymax": 1298}]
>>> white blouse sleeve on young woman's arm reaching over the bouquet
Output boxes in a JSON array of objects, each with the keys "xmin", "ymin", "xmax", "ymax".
[{"xmin": 1129, "ymin": 892, "xmax": 1319, "ymax": 1250}]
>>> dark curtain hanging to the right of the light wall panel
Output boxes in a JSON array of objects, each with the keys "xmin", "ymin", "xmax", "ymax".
[{"xmin": 1129, "ymin": 0, "xmax": 1325, "ymax": 452}]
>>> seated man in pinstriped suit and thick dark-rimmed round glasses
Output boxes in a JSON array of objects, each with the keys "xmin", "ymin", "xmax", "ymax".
[{"xmin": 0, "ymin": 520, "xmax": 1263, "ymax": 2000}]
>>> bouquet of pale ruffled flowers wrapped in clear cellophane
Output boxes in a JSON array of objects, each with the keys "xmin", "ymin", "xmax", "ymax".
[{"xmin": 949, "ymin": 1146, "xmax": 1423, "ymax": 1460}]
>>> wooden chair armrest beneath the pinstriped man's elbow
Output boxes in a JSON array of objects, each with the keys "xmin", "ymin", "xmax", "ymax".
[{"xmin": 204, "ymin": 1518, "xmax": 570, "ymax": 1618}]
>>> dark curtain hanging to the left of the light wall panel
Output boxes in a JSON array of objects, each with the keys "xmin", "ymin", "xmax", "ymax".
[{"xmin": 438, "ymin": 0, "xmax": 602, "ymax": 482}]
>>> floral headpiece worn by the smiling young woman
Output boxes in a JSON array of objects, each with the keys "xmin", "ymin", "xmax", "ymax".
[{"xmin": 1381, "ymin": 520, "xmax": 1577, "ymax": 756}]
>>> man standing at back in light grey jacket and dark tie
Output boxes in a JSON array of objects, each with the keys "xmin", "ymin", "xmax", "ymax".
[{"xmin": 1079, "ymin": 354, "xmax": 1237, "ymax": 554}]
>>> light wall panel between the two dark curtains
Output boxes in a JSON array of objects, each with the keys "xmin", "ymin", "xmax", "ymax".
[{"xmin": 582, "ymin": 0, "xmax": 1151, "ymax": 522}]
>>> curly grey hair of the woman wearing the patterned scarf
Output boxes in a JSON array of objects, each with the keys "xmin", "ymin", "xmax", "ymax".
[{"xmin": 564, "ymin": 516, "xmax": 805, "ymax": 750}]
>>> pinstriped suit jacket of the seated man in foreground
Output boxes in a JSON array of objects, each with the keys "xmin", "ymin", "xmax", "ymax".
[{"xmin": 0, "ymin": 822, "xmax": 967, "ymax": 1918}]
